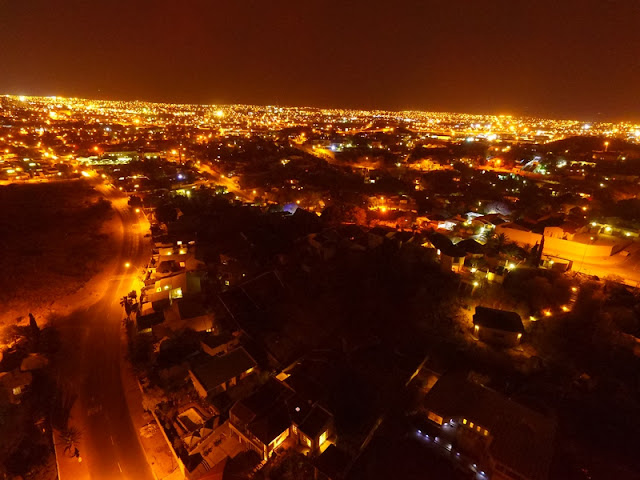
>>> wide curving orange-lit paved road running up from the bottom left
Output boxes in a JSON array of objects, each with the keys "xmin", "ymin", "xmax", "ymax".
[{"xmin": 54, "ymin": 190, "xmax": 153, "ymax": 480}]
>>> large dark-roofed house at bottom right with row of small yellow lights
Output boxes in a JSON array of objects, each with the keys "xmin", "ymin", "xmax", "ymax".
[{"xmin": 424, "ymin": 374, "xmax": 556, "ymax": 480}]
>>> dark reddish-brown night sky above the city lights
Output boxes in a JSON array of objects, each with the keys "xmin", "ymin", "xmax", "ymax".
[{"xmin": 0, "ymin": 0, "xmax": 640, "ymax": 120}]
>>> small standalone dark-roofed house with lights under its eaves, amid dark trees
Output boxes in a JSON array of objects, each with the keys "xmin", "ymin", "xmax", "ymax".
[{"xmin": 473, "ymin": 307, "xmax": 524, "ymax": 347}]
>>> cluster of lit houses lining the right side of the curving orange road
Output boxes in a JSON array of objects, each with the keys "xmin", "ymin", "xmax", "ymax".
[{"xmin": 132, "ymin": 233, "xmax": 350, "ymax": 479}]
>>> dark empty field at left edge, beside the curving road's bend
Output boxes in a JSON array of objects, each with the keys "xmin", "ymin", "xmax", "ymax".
[{"xmin": 0, "ymin": 180, "xmax": 114, "ymax": 324}]
